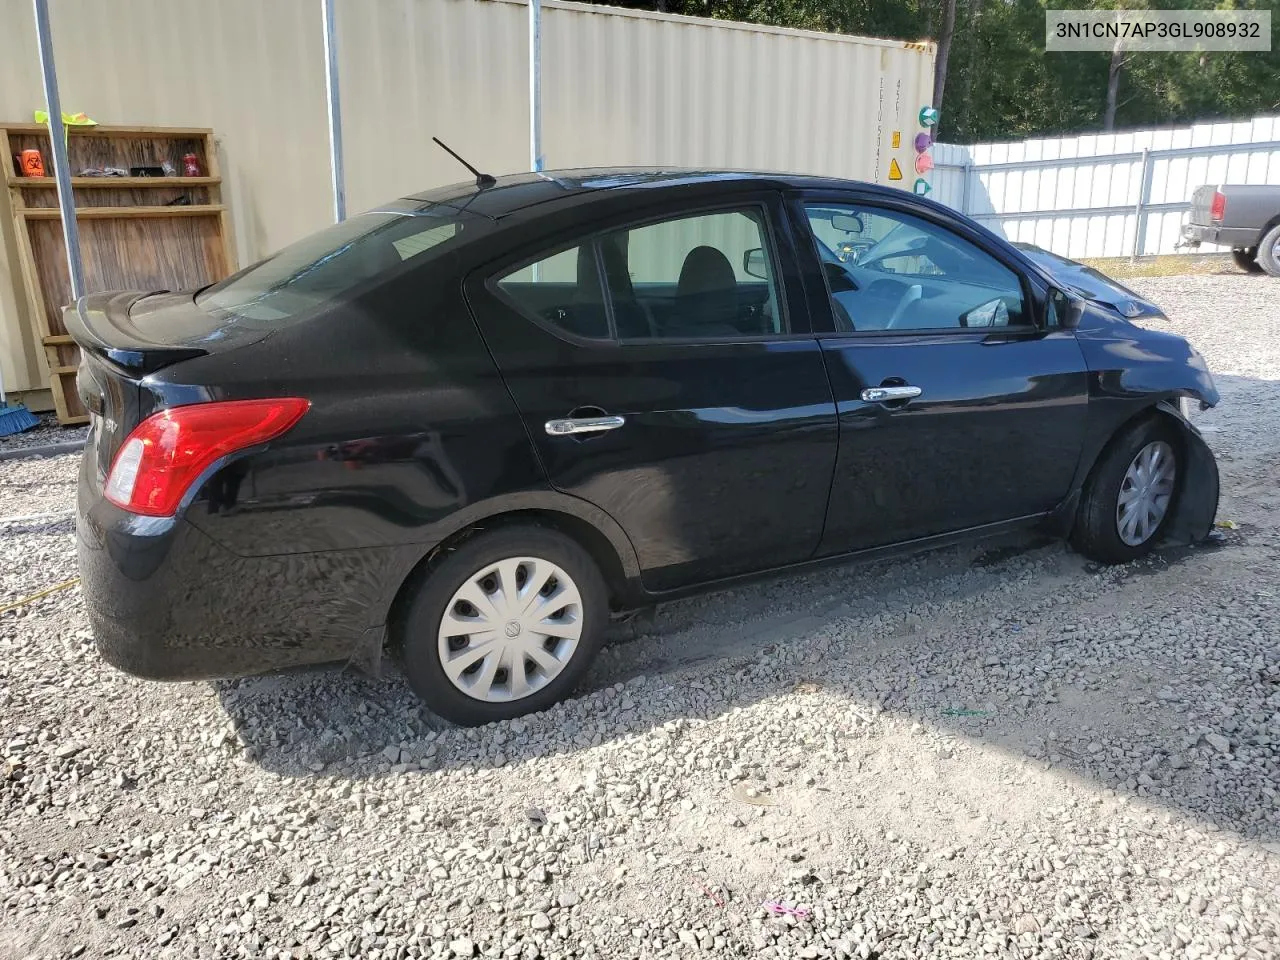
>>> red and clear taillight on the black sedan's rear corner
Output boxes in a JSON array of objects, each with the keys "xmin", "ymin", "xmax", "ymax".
[{"xmin": 105, "ymin": 397, "xmax": 311, "ymax": 517}]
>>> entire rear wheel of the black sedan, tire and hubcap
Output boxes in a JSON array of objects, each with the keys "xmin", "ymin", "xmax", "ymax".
[{"xmin": 401, "ymin": 526, "xmax": 609, "ymax": 726}]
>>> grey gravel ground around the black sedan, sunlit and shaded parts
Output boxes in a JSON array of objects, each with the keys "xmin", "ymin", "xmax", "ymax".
[{"xmin": 0, "ymin": 275, "xmax": 1280, "ymax": 960}]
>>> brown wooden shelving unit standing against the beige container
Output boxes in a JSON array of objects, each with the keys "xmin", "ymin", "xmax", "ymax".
[{"xmin": 0, "ymin": 123, "xmax": 236, "ymax": 424}]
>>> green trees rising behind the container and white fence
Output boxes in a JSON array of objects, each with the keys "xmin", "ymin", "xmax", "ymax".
[{"xmin": 601, "ymin": 0, "xmax": 1280, "ymax": 142}]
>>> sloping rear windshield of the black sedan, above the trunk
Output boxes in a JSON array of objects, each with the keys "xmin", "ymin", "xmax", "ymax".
[{"xmin": 196, "ymin": 201, "xmax": 485, "ymax": 323}]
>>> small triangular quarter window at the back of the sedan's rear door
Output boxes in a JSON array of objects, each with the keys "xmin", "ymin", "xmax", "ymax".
[{"xmin": 498, "ymin": 243, "xmax": 609, "ymax": 339}]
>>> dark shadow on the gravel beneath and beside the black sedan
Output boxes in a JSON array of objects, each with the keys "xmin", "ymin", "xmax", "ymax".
[{"xmin": 215, "ymin": 506, "xmax": 1280, "ymax": 838}]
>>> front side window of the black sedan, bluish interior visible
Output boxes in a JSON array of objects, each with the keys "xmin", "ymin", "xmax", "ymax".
[{"xmin": 805, "ymin": 204, "xmax": 1030, "ymax": 332}]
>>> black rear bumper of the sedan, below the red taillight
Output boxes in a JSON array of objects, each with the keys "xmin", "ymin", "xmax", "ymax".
[{"xmin": 77, "ymin": 448, "xmax": 408, "ymax": 680}]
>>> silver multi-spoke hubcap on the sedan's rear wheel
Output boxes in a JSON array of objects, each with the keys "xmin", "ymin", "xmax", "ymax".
[{"xmin": 439, "ymin": 557, "xmax": 582, "ymax": 703}]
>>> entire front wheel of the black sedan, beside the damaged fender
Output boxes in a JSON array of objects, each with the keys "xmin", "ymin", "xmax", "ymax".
[{"xmin": 1071, "ymin": 417, "xmax": 1184, "ymax": 563}]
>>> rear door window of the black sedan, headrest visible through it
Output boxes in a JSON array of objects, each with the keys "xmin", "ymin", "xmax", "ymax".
[{"xmin": 599, "ymin": 210, "xmax": 786, "ymax": 339}]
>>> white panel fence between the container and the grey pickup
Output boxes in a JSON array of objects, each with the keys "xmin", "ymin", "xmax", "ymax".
[{"xmin": 931, "ymin": 116, "xmax": 1280, "ymax": 257}]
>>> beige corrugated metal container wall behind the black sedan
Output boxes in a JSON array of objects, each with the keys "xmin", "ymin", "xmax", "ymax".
[{"xmin": 0, "ymin": 0, "xmax": 933, "ymax": 388}]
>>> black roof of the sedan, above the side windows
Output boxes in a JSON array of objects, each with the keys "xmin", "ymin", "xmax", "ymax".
[{"xmin": 406, "ymin": 166, "xmax": 901, "ymax": 220}]
